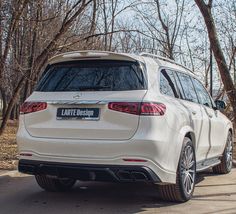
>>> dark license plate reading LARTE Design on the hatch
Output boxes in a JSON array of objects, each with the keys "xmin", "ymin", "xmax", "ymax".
[{"xmin": 57, "ymin": 108, "xmax": 99, "ymax": 120}]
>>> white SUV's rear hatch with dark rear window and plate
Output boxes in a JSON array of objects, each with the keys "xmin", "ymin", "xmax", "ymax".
[{"xmin": 24, "ymin": 60, "xmax": 147, "ymax": 140}]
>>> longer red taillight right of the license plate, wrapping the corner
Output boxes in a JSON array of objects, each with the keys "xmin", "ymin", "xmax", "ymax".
[{"xmin": 108, "ymin": 102, "xmax": 166, "ymax": 116}]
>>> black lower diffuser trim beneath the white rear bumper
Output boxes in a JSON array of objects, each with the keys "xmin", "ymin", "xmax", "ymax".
[{"xmin": 18, "ymin": 159, "xmax": 161, "ymax": 183}]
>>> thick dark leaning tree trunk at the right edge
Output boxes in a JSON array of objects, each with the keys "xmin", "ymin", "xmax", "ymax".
[{"xmin": 195, "ymin": 0, "xmax": 236, "ymax": 124}]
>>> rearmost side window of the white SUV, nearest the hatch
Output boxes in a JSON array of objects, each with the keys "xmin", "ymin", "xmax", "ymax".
[{"xmin": 160, "ymin": 70, "xmax": 179, "ymax": 98}]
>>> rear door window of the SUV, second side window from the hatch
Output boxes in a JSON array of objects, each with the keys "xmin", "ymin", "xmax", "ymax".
[{"xmin": 177, "ymin": 72, "xmax": 198, "ymax": 103}]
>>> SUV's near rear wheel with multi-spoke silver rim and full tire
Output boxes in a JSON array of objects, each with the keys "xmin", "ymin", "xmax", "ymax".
[{"xmin": 159, "ymin": 137, "xmax": 196, "ymax": 202}]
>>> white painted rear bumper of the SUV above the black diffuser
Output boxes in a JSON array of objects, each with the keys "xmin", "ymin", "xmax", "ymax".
[{"xmin": 17, "ymin": 115, "xmax": 177, "ymax": 183}]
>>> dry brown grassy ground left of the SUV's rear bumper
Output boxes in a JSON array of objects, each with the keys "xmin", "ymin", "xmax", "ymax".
[{"xmin": 0, "ymin": 122, "xmax": 18, "ymax": 170}]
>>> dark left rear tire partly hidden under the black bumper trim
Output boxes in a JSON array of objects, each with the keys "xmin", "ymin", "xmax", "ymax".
[{"xmin": 35, "ymin": 175, "xmax": 76, "ymax": 192}]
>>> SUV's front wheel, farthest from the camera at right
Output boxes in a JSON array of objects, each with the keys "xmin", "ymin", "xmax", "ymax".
[{"xmin": 212, "ymin": 132, "xmax": 233, "ymax": 174}]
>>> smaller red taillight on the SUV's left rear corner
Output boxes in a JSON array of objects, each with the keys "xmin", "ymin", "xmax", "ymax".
[{"xmin": 20, "ymin": 102, "xmax": 47, "ymax": 114}]
